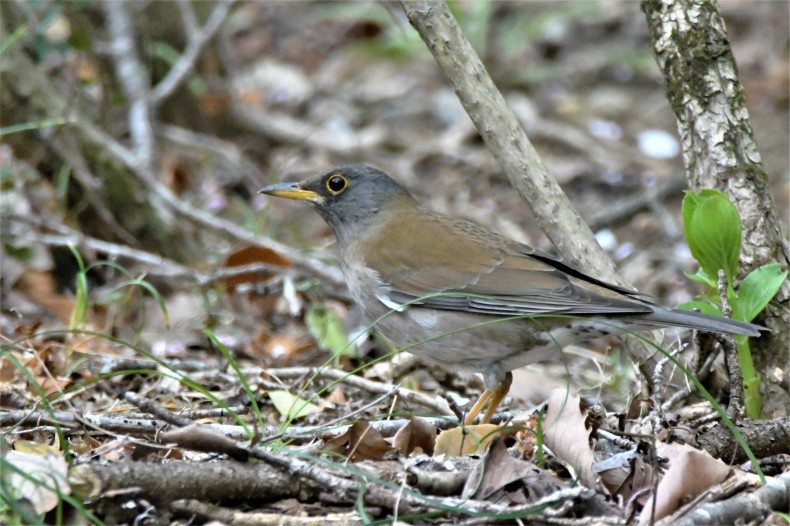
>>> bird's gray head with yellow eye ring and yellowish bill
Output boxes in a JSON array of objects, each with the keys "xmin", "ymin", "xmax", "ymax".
[{"xmin": 260, "ymin": 165, "xmax": 416, "ymax": 242}]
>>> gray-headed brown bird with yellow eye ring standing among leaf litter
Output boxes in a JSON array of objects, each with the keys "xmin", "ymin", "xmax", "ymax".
[{"xmin": 260, "ymin": 165, "xmax": 767, "ymax": 425}]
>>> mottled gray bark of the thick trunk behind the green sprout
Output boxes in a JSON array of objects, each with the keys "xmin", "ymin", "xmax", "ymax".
[{"xmin": 642, "ymin": 0, "xmax": 790, "ymax": 416}]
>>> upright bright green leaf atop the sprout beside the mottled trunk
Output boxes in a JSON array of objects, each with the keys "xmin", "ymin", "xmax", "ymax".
[{"xmin": 683, "ymin": 189, "xmax": 741, "ymax": 283}]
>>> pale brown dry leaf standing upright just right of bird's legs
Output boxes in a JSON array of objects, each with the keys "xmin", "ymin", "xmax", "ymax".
[{"xmin": 543, "ymin": 389, "xmax": 602, "ymax": 489}]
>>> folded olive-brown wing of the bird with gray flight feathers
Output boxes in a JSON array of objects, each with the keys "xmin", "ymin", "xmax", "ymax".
[{"xmin": 366, "ymin": 213, "xmax": 653, "ymax": 316}]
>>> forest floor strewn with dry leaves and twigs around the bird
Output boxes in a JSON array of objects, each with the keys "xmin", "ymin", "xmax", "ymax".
[{"xmin": 0, "ymin": 0, "xmax": 790, "ymax": 525}]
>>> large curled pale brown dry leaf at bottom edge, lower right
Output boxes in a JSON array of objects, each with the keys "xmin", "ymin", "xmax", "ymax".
[{"xmin": 639, "ymin": 443, "xmax": 731, "ymax": 524}]
